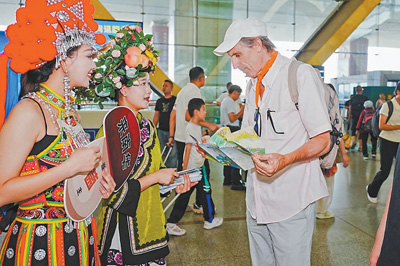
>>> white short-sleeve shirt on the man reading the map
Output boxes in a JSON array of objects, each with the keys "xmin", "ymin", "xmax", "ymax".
[{"xmin": 242, "ymin": 54, "xmax": 331, "ymax": 224}]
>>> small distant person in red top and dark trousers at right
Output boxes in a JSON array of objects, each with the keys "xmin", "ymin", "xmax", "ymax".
[{"xmin": 357, "ymin": 100, "xmax": 378, "ymax": 160}]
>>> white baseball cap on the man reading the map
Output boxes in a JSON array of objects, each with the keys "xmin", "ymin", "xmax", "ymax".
[{"xmin": 214, "ymin": 18, "xmax": 267, "ymax": 56}]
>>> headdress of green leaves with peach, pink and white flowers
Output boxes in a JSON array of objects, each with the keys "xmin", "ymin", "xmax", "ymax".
[{"xmin": 76, "ymin": 25, "xmax": 160, "ymax": 108}]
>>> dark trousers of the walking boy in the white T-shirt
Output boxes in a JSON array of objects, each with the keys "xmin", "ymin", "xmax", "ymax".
[{"xmin": 167, "ymin": 165, "xmax": 215, "ymax": 224}]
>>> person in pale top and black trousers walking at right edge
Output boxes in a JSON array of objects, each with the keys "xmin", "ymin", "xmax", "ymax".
[{"xmin": 367, "ymin": 83, "xmax": 400, "ymax": 203}]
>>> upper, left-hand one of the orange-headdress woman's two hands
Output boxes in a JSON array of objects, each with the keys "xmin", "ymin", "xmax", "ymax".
[{"xmin": 61, "ymin": 147, "xmax": 101, "ymax": 177}]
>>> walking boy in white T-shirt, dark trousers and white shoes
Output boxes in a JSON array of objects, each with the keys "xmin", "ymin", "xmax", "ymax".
[{"xmin": 167, "ymin": 98, "xmax": 223, "ymax": 235}]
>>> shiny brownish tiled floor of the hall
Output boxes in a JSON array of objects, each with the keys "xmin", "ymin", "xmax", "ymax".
[{"xmin": 0, "ymin": 148, "xmax": 392, "ymax": 266}]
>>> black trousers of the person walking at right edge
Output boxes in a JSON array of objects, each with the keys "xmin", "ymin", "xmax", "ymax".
[{"xmin": 368, "ymin": 138, "xmax": 399, "ymax": 198}]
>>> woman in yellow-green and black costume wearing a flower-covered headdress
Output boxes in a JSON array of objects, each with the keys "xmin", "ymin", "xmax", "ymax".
[{"xmin": 88, "ymin": 26, "xmax": 190, "ymax": 265}]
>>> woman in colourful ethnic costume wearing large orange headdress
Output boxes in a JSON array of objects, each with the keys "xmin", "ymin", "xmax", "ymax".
[{"xmin": 0, "ymin": 0, "xmax": 115, "ymax": 266}]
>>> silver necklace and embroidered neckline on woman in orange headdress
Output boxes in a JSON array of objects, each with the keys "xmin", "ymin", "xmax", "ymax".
[{"xmin": 24, "ymin": 84, "xmax": 89, "ymax": 157}]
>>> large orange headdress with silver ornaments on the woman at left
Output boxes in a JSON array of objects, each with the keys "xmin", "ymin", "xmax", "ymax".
[{"xmin": 0, "ymin": 0, "xmax": 106, "ymax": 128}]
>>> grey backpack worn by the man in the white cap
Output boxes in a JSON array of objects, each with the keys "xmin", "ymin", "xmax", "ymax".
[{"xmin": 288, "ymin": 60, "xmax": 343, "ymax": 169}]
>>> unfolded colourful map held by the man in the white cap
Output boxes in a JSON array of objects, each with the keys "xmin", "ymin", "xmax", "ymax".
[{"xmin": 191, "ymin": 127, "xmax": 265, "ymax": 171}]
